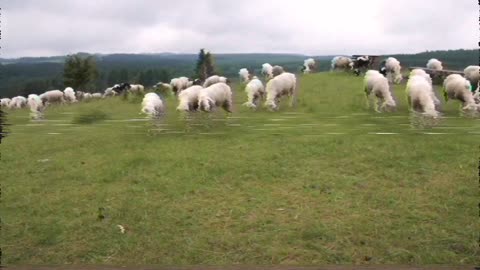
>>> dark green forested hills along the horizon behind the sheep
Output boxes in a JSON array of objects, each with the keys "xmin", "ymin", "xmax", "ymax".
[{"xmin": 0, "ymin": 50, "xmax": 479, "ymax": 97}]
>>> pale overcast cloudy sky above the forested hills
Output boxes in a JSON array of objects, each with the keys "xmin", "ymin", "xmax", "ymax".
[{"xmin": 0, "ymin": 0, "xmax": 479, "ymax": 58}]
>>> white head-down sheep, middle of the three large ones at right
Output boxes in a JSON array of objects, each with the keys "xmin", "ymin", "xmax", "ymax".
[{"xmin": 406, "ymin": 75, "xmax": 439, "ymax": 119}]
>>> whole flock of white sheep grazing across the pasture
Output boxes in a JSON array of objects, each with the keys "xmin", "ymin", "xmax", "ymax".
[{"xmin": 0, "ymin": 56, "xmax": 480, "ymax": 119}]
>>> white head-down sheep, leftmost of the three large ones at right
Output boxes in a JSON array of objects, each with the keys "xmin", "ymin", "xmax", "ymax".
[{"xmin": 363, "ymin": 70, "xmax": 396, "ymax": 112}]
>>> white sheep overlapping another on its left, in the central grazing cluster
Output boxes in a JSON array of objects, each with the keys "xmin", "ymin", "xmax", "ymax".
[{"xmin": 198, "ymin": 82, "xmax": 233, "ymax": 113}]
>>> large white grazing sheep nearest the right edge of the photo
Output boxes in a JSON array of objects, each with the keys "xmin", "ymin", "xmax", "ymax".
[{"xmin": 443, "ymin": 74, "xmax": 480, "ymax": 111}]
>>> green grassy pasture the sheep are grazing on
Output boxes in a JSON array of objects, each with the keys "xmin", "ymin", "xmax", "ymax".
[{"xmin": 0, "ymin": 73, "xmax": 480, "ymax": 265}]
